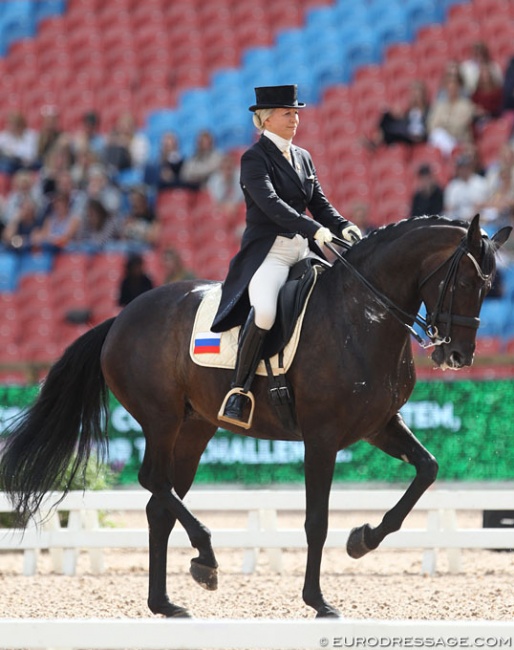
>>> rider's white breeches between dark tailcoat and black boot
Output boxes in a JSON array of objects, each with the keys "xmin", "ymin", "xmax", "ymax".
[{"xmin": 248, "ymin": 235, "xmax": 318, "ymax": 330}]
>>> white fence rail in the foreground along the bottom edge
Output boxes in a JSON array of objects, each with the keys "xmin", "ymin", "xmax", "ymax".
[{"xmin": 0, "ymin": 619, "xmax": 514, "ymax": 650}]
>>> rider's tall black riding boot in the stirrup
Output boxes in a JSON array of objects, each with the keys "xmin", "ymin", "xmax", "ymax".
[{"xmin": 218, "ymin": 307, "xmax": 268, "ymax": 429}]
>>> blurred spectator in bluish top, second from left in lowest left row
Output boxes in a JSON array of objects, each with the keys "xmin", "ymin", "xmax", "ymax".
[{"xmin": 32, "ymin": 192, "xmax": 81, "ymax": 252}]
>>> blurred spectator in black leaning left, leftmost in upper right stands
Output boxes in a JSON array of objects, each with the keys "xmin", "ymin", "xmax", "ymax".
[{"xmin": 365, "ymin": 81, "xmax": 430, "ymax": 150}]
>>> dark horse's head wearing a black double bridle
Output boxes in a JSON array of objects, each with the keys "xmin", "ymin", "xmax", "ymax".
[{"xmin": 421, "ymin": 215, "xmax": 512, "ymax": 370}]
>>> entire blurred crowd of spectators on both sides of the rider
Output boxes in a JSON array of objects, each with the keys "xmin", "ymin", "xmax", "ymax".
[{"xmin": 0, "ymin": 42, "xmax": 514, "ymax": 284}]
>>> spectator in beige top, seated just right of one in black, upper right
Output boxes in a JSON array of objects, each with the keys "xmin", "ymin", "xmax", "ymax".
[{"xmin": 427, "ymin": 70, "xmax": 475, "ymax": 156}]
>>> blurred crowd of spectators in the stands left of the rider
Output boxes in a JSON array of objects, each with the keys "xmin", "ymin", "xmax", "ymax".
[{"xmin": 0, "ymin": 106, "xmax": 231, "ymax": 266}]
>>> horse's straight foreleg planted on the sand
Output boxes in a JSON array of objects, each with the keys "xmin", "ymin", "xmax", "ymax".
[{"xmin": 302, "ymin": 446, "xmax": 341, "ymax": 618}]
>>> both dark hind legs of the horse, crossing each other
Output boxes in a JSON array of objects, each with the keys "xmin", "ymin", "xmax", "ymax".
[{"xmin": 139, "ymin": 421, "xmax": 217, "ymax": 617}]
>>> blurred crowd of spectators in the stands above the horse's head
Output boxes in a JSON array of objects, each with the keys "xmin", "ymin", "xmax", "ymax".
[{"xmin": 363, "ymin": 41, "xmax": 514, "ymax": 257}]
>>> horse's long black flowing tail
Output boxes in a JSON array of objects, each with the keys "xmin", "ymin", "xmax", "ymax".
[{"xmin": 0, "ymin": 318, "xmax": 114, "ymax": 525}]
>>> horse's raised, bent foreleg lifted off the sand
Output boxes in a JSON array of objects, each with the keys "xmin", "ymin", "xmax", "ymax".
[{"xmin": 346, "ymin": 414, "xmax": 438, "ymax": 558}]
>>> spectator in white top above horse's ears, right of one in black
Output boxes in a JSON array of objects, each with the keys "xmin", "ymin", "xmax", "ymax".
[{"xmin": 444, "ymin": 154, "xmax": 488, "ymax": 221}]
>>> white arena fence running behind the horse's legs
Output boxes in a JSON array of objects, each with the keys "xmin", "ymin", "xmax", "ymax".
[{"xmin": 0, "ymin": 489, "xmax": 514, "ymax": 576}]
